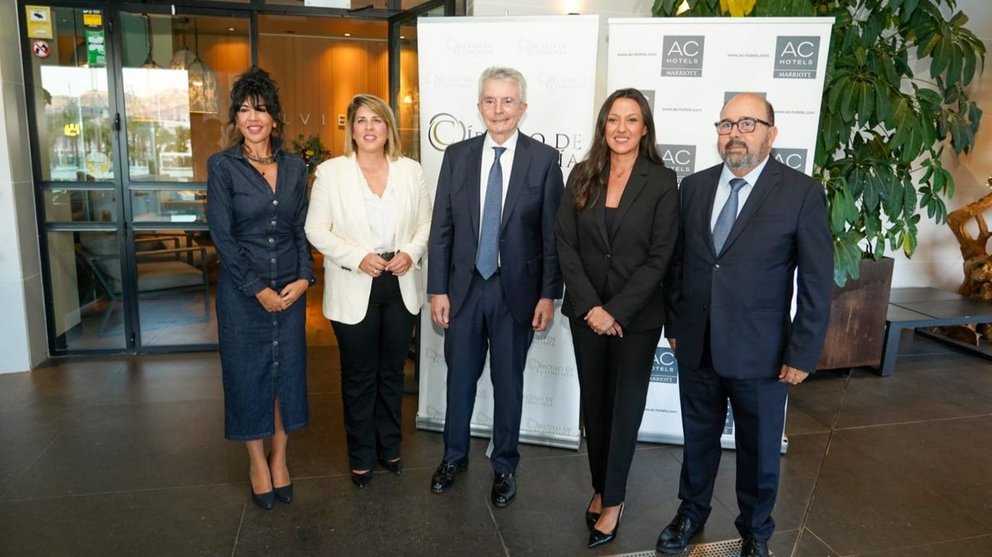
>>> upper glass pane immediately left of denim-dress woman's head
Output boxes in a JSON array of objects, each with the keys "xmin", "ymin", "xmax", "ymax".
[{"xmin": 121, "ymin": 13, "xmax": 250, "ymax": 182}]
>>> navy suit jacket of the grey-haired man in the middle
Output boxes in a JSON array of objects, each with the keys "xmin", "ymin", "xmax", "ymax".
[{"xmin": 427, "ymin": 132, "xmax": 563, "ymax": 323}]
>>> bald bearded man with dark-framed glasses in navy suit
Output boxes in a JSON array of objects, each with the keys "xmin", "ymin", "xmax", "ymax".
[{"xmin": 657, "ymin": 94, "xmax": 833, "ymax": 557}]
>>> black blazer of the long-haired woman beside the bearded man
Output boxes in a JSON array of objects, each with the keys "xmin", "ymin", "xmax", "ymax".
[{"xmin": 557, "ymin": 157, "xmax": 679, "ymax": 331}]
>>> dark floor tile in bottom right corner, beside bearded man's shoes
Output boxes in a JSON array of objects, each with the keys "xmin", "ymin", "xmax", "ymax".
[{"xmin": 806, "ymin": 426, "xmax": 988, "ymax": 555}]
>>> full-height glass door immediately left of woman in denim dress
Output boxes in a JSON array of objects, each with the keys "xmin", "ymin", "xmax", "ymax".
[{"xmin": 120, "ymin": 12, "xmax": 250, "ymax": 347}]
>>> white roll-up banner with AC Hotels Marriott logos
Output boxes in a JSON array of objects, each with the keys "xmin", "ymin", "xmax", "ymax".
[{"xmin": 607, "ymin": 18, "xmax": 833, "ymax": 452}]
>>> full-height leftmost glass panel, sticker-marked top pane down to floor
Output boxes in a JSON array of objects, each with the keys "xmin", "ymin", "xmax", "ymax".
[{"xmin": 28, "ymin": 7, "xmax": 127, "ymax": 351}]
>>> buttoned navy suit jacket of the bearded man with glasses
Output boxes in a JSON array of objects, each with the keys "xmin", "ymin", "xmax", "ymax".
[{"xmin": 666, "ymin": 159, "xmax": 833, "ymax": 379}]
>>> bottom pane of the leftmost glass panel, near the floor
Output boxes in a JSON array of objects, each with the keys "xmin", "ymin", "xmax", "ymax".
[{"xmin": 48, "ymin": 231, "xmax": 125, "ymax": 350}]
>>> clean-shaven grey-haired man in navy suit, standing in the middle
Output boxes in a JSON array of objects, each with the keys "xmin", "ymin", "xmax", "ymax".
[{"xmin": 427, "ymin": 67, "xmax": 564, "ymax": 507}]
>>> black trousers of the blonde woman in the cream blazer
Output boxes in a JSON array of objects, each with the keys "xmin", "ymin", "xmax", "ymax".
[{"xmin": 331, "ymin": 273, "xmax": 417, "ymax": 470}]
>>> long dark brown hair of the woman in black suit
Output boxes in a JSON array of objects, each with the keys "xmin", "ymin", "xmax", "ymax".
[{"xmin": 569, "ymin": 89, "xmax": 662, "ymax": 210}]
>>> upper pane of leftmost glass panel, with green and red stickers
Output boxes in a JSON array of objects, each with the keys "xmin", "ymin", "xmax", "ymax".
[{"xmin": 28, "ymin": 7, "xmax": 114, "ymax": 182}]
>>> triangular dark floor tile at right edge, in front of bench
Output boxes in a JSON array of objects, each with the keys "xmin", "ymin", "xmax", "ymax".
[{"xmin": 839, "ymin": 415, "xmax": 992, "ymax": 532}]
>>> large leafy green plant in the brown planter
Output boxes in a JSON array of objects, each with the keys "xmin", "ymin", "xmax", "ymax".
[{"xmin": 652, "ymin": 0, "xmax": 986, "ymax": 286}]
